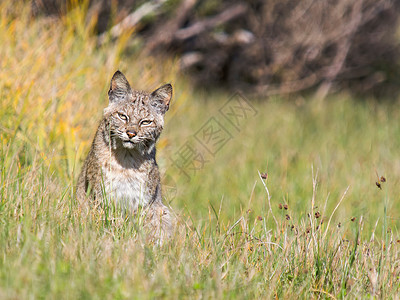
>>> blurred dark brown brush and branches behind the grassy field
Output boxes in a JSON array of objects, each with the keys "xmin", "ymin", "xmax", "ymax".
[{"xmin": 31, "ymin": 0, "xmax": 400, "ymax": 98}]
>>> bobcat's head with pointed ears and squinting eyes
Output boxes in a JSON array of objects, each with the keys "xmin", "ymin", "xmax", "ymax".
[{"xmin": 104, "ymin": 71, "xmax": 172, "ymax": 153}]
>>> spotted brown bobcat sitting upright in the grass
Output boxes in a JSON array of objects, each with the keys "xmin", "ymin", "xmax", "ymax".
[{"xmin": 77, "ymin": 71, "xmax": 172, "ymax": 236}]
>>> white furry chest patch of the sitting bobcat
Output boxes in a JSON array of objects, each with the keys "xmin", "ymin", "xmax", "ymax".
[{"xmin": 102, "ymin": 156, "xmax": 151, "ymax": 210}]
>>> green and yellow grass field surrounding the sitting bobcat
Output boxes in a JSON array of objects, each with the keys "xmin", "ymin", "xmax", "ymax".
[{"xmin": 0, "ymin": 2, "xmax": 400, "ymax": 299}]
